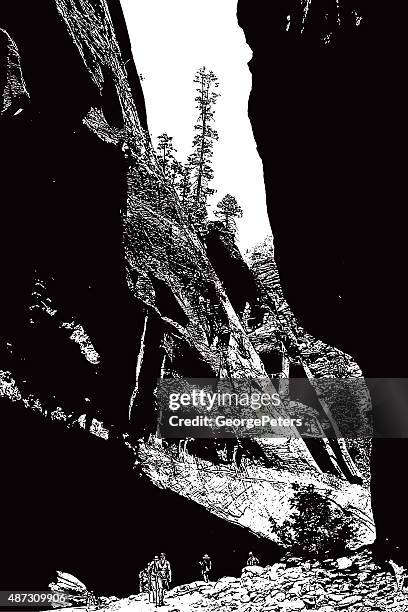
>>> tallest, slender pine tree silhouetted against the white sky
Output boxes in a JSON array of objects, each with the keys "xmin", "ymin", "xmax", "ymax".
[{"xmin": 188, "ymin": 66, "xmax": 219, "ymax": 231}]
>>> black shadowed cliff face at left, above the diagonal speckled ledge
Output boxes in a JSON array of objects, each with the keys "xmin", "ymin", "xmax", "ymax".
[{"xmin": 0, "ymin": 1, "xmax": 140, "ymax": 430}]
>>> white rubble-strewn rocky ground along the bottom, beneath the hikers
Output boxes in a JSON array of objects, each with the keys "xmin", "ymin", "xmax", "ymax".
[{"xmin": 55, "ymin": 552, "xmax": 408, "ymax": 612}]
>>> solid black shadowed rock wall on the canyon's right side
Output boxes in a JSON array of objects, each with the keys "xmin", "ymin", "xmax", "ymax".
[{"xmin": 238, "ymin": 0, "xmax": 408, "ymax": 556}]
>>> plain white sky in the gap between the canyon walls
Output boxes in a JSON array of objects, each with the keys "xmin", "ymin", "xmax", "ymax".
[{"xmin": 121, "ymin": 0, "xmax": 270, "ymax": 251}]
